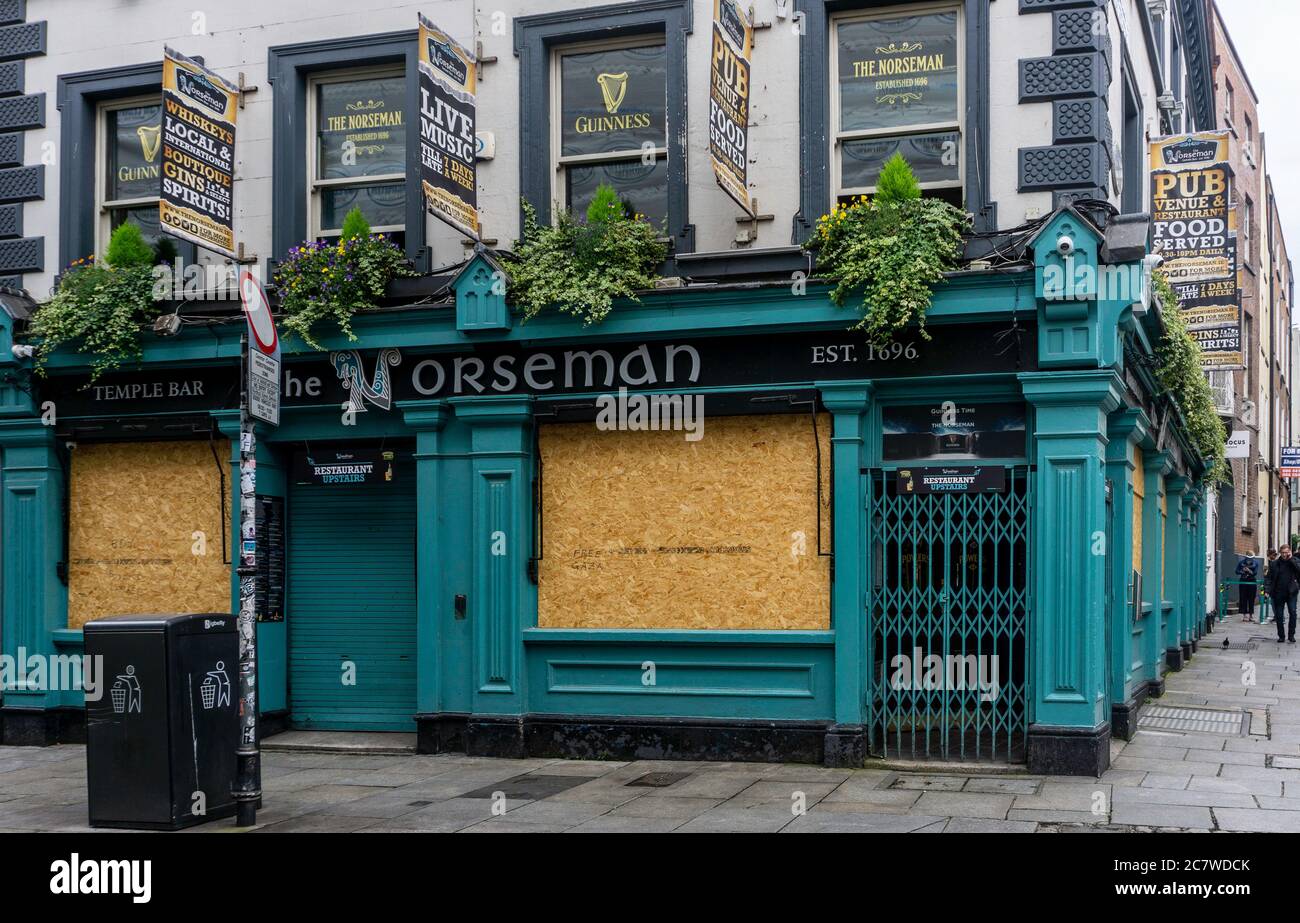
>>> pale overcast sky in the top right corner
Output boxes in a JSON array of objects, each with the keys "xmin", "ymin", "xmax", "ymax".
[{"xmin": 1217, "ymin": 0, "xmax": 1300, "ymax": 264}]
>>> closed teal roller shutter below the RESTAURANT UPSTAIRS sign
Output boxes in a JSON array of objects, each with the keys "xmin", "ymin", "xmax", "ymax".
[{"xmin": 287, "ymin": 478, "xmax": 416, "ymax": 731}]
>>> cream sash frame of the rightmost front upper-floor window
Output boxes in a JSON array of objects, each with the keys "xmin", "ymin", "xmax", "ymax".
[{"xmin": 827, "ymin": 1, "xmax": 966, "ymax": 202}]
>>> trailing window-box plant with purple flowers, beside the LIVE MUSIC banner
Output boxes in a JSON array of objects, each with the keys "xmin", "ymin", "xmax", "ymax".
[{"xmin": 274, "ymin": 208, "xmax": 415, "ymax": 350}]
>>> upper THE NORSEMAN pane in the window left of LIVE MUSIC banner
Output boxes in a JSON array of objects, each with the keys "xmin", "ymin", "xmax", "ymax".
[{"xmin": 316, "ymin": 77, "xmax": 406, "ymax": 179}]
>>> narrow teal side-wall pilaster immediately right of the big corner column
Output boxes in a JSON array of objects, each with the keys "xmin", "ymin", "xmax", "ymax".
[{"xmin": 1106, "ymin": 407, "xmax": 1151, "ymax": 740}]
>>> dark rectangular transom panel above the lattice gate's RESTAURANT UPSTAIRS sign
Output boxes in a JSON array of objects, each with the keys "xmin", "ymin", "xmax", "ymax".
[{"xmin": 880, "ymin": 400, "xmax": 1027, "ymax": 462}]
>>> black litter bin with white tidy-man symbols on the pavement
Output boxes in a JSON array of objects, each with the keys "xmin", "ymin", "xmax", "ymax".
[{"xmin": 85, "ymin": 612, "xmax": 239, "ymax": 829}]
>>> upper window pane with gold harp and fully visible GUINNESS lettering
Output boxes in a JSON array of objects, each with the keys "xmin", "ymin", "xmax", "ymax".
[{"xmin": 560, "ymin": 46, "xmax": 668, "ymax": 156}]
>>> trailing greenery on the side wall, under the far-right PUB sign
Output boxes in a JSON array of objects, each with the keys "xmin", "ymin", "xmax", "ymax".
[{"xmin": 1152, "ymin": 269, "xmax": 1227, "ymax": 484}]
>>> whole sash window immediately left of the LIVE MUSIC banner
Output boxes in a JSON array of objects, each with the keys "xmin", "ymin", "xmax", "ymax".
[{"xmin": 307, "ymin": 69, "xmax": 407, "ymax": 243}]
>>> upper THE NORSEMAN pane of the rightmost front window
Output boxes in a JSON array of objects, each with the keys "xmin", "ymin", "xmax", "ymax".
[{"xmin": 839, "ymin": 12, "xmax": 958, "ymax": 131}]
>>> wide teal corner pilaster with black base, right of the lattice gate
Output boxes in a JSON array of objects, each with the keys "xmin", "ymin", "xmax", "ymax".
[{"xmin": 1021, "ymin": 369, "xmax": 1122, "ymax": 776}]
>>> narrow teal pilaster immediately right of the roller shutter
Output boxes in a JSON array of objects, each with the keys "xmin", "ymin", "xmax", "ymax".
[{"xmin": 398, "ymin": 400, "xmax": 452, "ymax": 753}]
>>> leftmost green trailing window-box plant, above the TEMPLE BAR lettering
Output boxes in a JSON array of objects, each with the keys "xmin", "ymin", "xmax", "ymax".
[{"xmin": 27, "ymin": 221, "xmax": 166, "ymax": 381}]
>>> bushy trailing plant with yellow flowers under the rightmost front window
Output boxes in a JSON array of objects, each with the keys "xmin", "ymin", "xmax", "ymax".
[{"xmin": 806, "ymin": 153, "xmax": 970, "ymax": 346}]
